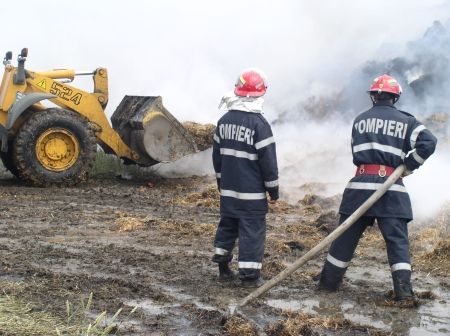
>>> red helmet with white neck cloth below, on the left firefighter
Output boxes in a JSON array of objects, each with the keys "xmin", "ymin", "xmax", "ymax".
[{"xmin": 234, "ymin": 69, "xmax": 267, "ymax": 97}]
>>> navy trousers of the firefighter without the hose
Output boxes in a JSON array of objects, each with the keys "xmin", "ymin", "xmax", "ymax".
[{"xmin": 214, "ymin": 216, "xmax": 266, "ymax": 280}]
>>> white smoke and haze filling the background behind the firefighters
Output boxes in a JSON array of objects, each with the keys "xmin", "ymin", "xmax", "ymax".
[{"xmin": 0, "ymin": 0, "xmax": 450, "ymax": 218}]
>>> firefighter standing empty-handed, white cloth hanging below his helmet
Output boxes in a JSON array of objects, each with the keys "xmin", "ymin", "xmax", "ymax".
[{"xmin": 212, "ymin": 69, "xmax": 278, "ymax": 287}]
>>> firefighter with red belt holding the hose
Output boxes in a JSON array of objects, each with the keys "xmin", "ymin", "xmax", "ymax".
[{"xmin": 319, "ymin": 75, "xmax": 437, "ymax": 300}]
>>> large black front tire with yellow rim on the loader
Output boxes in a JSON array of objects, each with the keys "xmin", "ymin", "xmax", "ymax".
[{"xmin": 13, "ymin": 108, "xmax": 97, "ymax": 187}]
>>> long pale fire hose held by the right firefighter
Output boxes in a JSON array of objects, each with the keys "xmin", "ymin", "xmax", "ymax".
[{"xmin": 227, "ymin": 165, "xmax": 405, "ymax": 316}]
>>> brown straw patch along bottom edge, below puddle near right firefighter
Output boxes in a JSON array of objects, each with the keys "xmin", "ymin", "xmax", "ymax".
[{"xmin": 264, "ymin": 312, "xmax": 389, "ymax": 336}]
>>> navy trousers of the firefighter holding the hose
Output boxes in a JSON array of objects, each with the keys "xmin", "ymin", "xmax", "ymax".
[{"xmin": 323, "ymin": 215, "xmax": 411, "ymax": 286}]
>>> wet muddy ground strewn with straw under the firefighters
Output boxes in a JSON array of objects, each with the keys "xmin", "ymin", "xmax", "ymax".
[{"xmin": 0, "ymin": 168, "xmax": 450, "ymax": 335}]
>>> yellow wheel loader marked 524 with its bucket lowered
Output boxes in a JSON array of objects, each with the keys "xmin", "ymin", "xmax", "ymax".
[{"xmin": 0, "ymin": 48, "xmax": 197, "ymax": 186}]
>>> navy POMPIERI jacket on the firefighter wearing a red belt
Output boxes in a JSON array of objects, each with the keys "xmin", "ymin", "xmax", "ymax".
[{"xmin": 339, "ymin": 102, "xmax": 437, "ymax": 220}]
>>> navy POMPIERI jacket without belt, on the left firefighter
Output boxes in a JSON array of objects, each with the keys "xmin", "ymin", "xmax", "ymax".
[{"xmin": 212, "ymin": 110, "xmax": 278, "ymax": 218}]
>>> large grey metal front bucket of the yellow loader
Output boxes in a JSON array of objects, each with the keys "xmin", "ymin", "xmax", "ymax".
[{"xmin": 111, "ymin": 96, "xmax": 197, "ymax": 166}]
